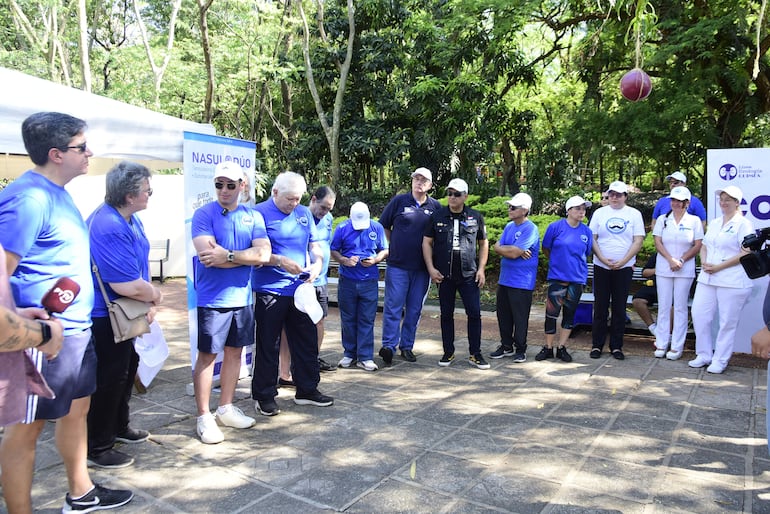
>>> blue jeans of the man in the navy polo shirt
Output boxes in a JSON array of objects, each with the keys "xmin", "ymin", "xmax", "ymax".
[{"xmin": 382, "ymin": 266, "xmax": 430, "ymax": 350}]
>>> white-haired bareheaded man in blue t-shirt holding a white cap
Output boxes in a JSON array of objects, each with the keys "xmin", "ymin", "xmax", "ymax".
[{"xmin": 251, "ymin": 171, "xmax": 334, "ymax": 416}]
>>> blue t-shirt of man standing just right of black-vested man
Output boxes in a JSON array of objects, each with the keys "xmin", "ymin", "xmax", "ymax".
[{"xmin": 497, "ymin": 220, "xmax": 540, "ymax": 290}]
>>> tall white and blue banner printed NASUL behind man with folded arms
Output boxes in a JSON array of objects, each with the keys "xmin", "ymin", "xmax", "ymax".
[{"xmin": 184, "ymin": 132, "xmax": 257, "ymax": 382}]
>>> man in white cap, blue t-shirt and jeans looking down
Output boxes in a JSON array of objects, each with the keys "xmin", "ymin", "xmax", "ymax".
[{"xmin": 331, "ymin": 202, "xmax": 388, "ymax": 371}]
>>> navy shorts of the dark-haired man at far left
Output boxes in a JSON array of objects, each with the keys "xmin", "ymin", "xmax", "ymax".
[{"xmin": 24, "ymin": 328, "xmax": 96, "ymax": 423}]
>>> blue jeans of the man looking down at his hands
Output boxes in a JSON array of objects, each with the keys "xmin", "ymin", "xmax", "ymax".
[{"xmin": 337, "ymin": 277, "xmax": 379, "ymax": 361}]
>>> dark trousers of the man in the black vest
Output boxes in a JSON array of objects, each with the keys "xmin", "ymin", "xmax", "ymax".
[{"xmin": 438, "ymin": 276, "xmax": 481, "ymax": 355}]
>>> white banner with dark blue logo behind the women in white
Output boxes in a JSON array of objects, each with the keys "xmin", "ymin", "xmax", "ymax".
[{"xmin": 704, "ymin": 148, "xmax": 770, "ymax": 353}]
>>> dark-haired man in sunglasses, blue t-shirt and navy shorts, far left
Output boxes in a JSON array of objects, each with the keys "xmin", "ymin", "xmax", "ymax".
[{"xmin": 0, "ymin": 112, "xmax": 134, "ymax": 512}]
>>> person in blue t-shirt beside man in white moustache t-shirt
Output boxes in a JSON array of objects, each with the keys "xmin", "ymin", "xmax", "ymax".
[{"xmin": 535, "ymin": 196, "xmax": 593, "ymax": 362}]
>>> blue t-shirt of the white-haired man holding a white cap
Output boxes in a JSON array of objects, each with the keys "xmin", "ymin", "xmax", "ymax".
[{"xmin": 251, "ymin": 197, "xmax": 318, "ymax": 296}]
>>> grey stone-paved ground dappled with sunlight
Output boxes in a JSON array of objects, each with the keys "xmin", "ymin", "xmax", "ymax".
[{"xmin": 4, "ymin": 280, "xmax": 770, "ymax": 513}]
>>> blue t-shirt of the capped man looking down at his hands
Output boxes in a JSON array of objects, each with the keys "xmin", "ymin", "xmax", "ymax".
[{"xmin": 331, "ymin": 220, "xmax": 388, "ymax": 280}]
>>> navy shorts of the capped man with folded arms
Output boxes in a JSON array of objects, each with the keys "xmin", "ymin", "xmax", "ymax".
[{"xmin": 198, "ymin": 305, "xmax": 256, "ymax": 353}]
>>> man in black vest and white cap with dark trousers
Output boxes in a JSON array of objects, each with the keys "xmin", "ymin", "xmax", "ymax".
[{"xmin": 422, "ymin": 178, "xmax": 489, "ymax": 369}]
